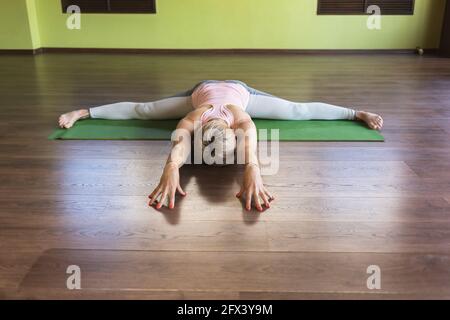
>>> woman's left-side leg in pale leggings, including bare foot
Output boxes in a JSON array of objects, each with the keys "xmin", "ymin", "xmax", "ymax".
[{"xmin": 59, "ymin": 91, "xmax": 192, "ymax": 128}]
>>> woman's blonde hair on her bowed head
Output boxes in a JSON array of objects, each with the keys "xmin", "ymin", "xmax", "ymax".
[{"xmin": 201, "ymin": 119, "xmax": 236, "ymax": 165}]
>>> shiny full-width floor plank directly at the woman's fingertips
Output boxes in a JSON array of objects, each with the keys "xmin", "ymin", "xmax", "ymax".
[{"xmin": 0, "ymin": 194, "xmax": 450, "ymax": 224}]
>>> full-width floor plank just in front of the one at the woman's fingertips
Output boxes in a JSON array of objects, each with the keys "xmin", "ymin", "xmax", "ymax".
[{"xmin": 0, "ymin": 222, "xmax": 450, "ymax": 253}]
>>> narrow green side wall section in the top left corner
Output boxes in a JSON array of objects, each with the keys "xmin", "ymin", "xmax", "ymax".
[{"xmin": 0, "ymin": 0, "xmax": 32, "ymax": 49}]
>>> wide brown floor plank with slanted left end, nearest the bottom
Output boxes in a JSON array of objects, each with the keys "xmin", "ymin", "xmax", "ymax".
[{"xmin": 20, "ymin": 250, "xmax": 450, "ymax": 295}]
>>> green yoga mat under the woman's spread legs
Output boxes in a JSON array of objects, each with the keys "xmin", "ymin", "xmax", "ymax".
[{"xmin": 48, "ymin": 119, "xmax": 384, "ymax": 141}]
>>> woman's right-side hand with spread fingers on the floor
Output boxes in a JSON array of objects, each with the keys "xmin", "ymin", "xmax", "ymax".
[{"xmin": 236, "ymin": 164, "xmax": 275, "ymax": 211}]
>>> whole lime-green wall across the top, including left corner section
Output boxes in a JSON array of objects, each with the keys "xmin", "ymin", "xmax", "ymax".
[{"xmin": 0, "ymin": 0, "xmax": 445, "ymax": 49}]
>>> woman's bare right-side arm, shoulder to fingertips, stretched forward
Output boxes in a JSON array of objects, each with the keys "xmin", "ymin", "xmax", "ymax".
[{"xmin": 235, "ymin": 117, "xmax": 275, "ymax": 211}]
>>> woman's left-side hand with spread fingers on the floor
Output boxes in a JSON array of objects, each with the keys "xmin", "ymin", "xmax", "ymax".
[{"xmin": 148, "ymin": 162, "xmax": 186, "ymax": 209}]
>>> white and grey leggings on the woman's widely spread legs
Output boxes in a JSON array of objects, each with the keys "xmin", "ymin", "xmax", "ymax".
[{"xmin": 89, "ymin": 80, "xmax": 356, "ymax": 120}]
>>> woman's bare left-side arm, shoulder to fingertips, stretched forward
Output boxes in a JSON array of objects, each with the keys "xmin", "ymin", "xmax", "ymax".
[{"xmin": 149, "ymin": 116, "xmax": 194, "ymax": 209}]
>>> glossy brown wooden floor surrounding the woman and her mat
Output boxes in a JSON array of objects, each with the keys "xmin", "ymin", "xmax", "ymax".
[{"xmin": 0, "ymin": 54, "xmax": 450, "ymax": 299}]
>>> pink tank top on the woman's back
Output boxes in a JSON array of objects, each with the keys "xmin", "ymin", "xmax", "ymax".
[{"xmin": 191, "ymin": 82, "xmax": 250, "ymax": 127}]
